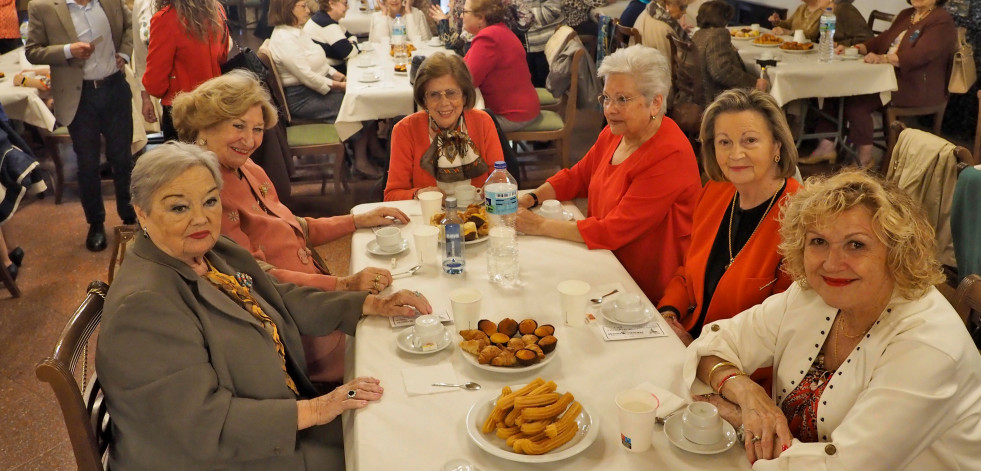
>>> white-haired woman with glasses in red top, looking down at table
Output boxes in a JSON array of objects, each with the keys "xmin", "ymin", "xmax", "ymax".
[{"xmin": 517, "ymin": 45, "xmax": 701, "ymax": 299}]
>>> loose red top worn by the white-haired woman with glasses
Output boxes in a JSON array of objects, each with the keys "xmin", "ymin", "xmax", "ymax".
[{"xmin": 548, "ymin": 117, "xmax": 702, "ymax": 301}]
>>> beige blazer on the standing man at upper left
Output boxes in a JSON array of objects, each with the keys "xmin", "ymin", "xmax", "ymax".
[{"xmin": 24, "ymin": 0, "xmax": 133, "ymax": 126}]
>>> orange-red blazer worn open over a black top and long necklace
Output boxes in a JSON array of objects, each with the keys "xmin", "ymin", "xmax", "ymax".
[{"xmin": 658, "ymin": 178, "xmax": 800, "ymax": 330}]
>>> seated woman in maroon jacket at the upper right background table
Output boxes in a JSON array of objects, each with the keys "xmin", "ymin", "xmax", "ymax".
[{"xmin": 801, "ymin": 0, "xmax": 957, "ymax": 167}]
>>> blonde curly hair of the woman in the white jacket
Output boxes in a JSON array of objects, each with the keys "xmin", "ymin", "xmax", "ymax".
[{"xmin": 778, "ymin": 170, "xmax": 945, "ymax": 299}]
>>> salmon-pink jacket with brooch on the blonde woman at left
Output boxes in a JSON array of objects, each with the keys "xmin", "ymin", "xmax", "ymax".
[{"xmin": 221, "ymin": 159, "xmax": 355, "ymax": 291}]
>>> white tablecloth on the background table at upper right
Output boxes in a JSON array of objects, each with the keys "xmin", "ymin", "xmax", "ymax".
[{"xmin": 732, "ymin": 36, "xmax": 899, "ymax": 106}]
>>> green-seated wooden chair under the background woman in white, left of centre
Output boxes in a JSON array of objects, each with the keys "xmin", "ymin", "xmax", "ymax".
[{"xmin": 257, "ymin": 40, "xmax": 350, "ymax": 195}]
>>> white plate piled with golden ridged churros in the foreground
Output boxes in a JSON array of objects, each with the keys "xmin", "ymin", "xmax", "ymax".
[{"xmin": 467, "ymin": 378, "xmax": 599, "ymax": 463}]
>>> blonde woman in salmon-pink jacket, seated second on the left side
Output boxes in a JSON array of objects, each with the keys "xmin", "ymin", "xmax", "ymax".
[{"xmin": 174, "ymin": 71, "xmax": 409, "ymax": 382}]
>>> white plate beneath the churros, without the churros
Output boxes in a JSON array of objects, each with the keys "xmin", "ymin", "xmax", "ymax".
[{"xmin": 467, "ymin": 386, "xmax": 599, "ymax": 463}]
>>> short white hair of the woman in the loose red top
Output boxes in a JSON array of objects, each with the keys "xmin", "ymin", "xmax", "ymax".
[{"xmin": 597, "ymin": 44, "xmax": 671, "ymax": 102}]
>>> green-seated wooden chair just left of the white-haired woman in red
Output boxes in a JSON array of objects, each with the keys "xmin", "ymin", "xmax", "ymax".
[{"xmin": 505, "ymin": 49, "xmax": 586, "ymax": 181}]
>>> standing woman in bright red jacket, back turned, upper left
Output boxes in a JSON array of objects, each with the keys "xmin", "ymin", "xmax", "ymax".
[{"xmin": 143, "ymin": 0, "xmax": 229, "ymax": 140}]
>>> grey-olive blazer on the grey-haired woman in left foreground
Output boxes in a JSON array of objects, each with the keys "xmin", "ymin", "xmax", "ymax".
[{"xmin": 95, "ymin": 236, "xmax": 367, "ymax": 471}]
